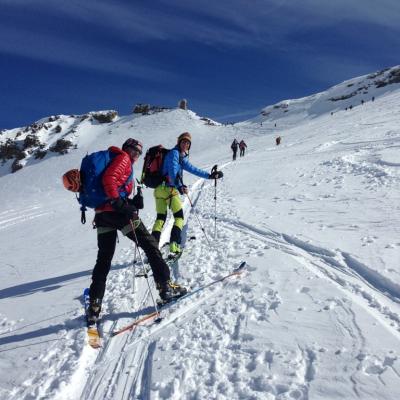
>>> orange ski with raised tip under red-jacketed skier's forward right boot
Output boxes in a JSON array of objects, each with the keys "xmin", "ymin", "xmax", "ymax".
[{"xmin": 111, "ymin": 261, "xmax": 246, "ymax": 337}]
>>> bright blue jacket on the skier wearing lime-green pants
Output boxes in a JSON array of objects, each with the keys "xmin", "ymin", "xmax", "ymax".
[{"xmin": 162, "ymin": 146, "xmax": 210, "ymax": 188}]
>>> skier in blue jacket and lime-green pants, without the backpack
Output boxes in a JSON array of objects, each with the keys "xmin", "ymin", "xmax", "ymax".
[{"xmin": 152, "ymin": 132, "xmax": 223, "ymax": 254}]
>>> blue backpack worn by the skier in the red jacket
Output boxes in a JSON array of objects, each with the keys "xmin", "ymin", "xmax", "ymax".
[{"xmin": 78, "ymin": 150, "xmax": 133, "ymax": 224}]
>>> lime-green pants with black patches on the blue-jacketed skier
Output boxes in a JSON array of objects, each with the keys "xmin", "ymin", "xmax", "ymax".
[{"xmin": 152, "ymin": 185, "xmax": 184, "ymax": 244}]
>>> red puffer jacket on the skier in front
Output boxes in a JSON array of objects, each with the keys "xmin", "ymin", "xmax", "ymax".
[{"xmin": 96, "ymin": 146, "xmax": 134, "ymax": 212}]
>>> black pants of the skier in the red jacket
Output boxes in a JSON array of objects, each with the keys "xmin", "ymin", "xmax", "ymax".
[{"xmin": 90, "ymin": 211, "xmax": 170, "ymax": 299}]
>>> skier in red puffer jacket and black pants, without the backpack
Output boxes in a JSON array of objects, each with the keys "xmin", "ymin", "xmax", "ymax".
[{"xmin": 87, "ymin": 138, "xmax": 186, "ymax": 322}]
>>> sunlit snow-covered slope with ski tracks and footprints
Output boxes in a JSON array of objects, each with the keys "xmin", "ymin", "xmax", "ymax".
[{"xmin": 0, "ymin": 72, "xmax": 400, "ymax": 400}]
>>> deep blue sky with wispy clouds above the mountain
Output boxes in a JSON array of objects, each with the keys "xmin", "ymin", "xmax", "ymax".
[{"xmin": 0, "ymin": 0, "xmax": 400, "ymax": 129}]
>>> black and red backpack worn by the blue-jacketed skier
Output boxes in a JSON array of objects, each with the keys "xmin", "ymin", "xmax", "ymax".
[{"xmin": 140, "ymin": 144, "xmax": 169, "ymax": 189}]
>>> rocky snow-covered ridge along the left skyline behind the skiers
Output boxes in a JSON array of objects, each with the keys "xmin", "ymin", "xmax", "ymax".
[{"xmin": 0, "ymin": 109, "xmax": 225, "ymax": 177}]
